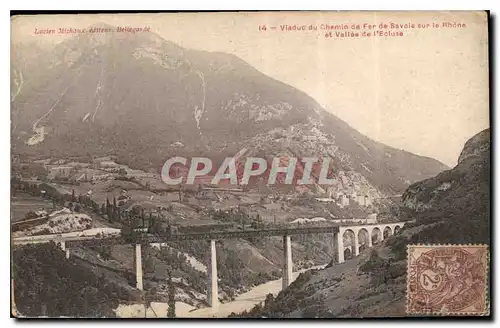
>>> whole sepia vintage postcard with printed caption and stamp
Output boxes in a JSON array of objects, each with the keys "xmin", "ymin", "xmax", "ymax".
[{"xmin": 10, "ymin": 11, "xmax": 491, "ymax": 319}]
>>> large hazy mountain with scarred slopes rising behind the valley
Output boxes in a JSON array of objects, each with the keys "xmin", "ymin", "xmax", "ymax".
[{"xmin": 12, "ymin": 27, "xmax": 447, "ymax": 194}]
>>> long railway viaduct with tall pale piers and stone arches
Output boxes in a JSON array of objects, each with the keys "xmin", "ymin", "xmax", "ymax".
[{"xmin": 13, "ymin": 222, "xmax": 405, "ymax": 309}]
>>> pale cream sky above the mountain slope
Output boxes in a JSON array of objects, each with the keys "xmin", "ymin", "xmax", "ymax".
[{"xmin": 11, "ymin": 12, "xmax": 489, "ymax": 167}]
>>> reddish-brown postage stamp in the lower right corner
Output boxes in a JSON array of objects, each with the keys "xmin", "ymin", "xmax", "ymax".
[{"xmin": 406, "ymin": 245, "xmax": 489, "ymax": 316}]
